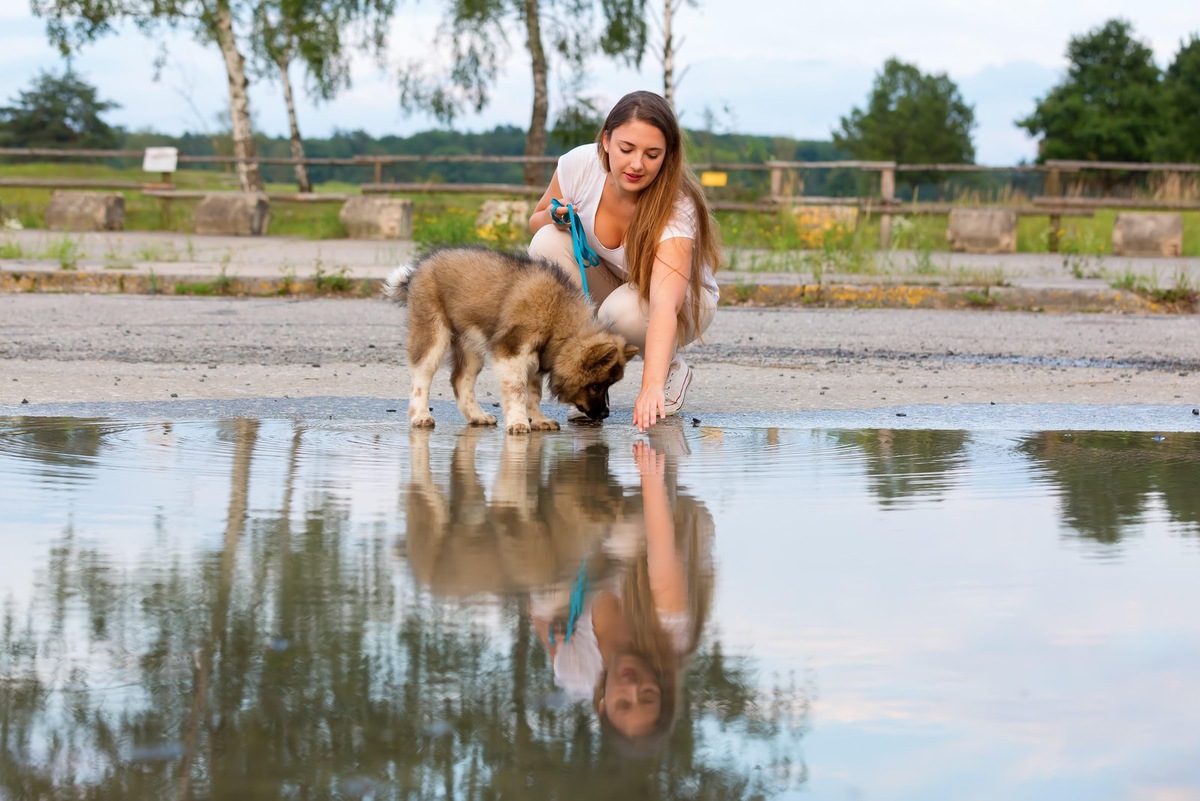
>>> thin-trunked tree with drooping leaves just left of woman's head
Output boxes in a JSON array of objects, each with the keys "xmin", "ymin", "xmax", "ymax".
[{"xmin": 401, "ymin": 0, "xmax": 647, "ymax": 186}]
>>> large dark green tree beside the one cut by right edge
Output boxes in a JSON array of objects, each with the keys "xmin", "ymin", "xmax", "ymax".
[{"xmin": 1016, "ymin": 19, "xmax": 1163, "ymax": 162}]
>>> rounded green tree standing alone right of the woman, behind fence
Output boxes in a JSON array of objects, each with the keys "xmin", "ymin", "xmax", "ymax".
[{"xmin": 833, "ymin": 59, "xmax": 976, "ymax": 164}]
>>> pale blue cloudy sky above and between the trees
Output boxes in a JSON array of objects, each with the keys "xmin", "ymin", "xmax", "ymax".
[{"xmin": 0, "ymin": 0, "xmax": 1200, "ymax": 165}]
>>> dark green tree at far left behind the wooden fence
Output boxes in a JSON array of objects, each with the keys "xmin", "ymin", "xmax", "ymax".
[{"xmin": 0, "ymin": 67, "xmax": 120, "ymax": 150}]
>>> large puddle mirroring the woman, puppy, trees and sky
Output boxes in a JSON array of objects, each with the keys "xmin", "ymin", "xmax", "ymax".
[{"xmin": 0, "ymin": 416, "xmax": 1200, "ymax": 801}]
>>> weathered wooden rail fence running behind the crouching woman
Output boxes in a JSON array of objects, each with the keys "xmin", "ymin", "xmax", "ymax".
[{"xmin": 0, "ymin": 147, "xmax": 1200, "ymax": 249}]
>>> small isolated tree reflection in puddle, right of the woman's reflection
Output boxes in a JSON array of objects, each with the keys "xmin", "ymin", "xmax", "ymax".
[{"xmin": 833, "ymin": 428, "xmax": 967, "ymax": 506}]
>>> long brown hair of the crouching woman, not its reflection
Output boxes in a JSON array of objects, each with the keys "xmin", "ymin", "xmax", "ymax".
[{"xmin": 596, "ymin": 91, "xmax": 721, "ymax": 338}]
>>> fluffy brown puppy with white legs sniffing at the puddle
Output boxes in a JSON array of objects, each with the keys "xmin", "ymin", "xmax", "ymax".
[{"xmin": 384, "ymin": 247, "xmax": 637, "ymax": 434}]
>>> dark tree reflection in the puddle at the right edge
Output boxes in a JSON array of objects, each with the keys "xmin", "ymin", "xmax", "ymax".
[{"xmin": 1020, "ymin": 432, "xmax": 1200, "ymax": 544}]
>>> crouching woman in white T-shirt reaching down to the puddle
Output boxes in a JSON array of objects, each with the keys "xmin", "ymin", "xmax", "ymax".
[{"xmin": 529, "ymin": 91, "xmax": 721, "ymax": 432}]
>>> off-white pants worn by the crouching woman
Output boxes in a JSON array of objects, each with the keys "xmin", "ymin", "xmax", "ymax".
[{"xmin": 529, "ymin": 225, "xmax": 716, "ymax": 353}]
